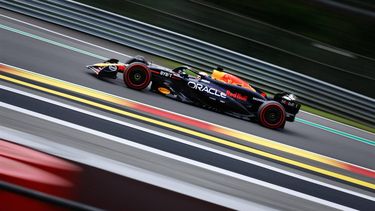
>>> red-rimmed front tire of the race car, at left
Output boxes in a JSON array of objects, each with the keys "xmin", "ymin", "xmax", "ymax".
[{"xmin": 124, "ymin": 62, "xmax": 151, "ymax": 90}]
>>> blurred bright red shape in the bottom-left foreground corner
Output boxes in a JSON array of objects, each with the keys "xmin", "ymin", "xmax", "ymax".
[{"xmin": 0, "ymin": 139, "xmax": 81, "ymax": 210}]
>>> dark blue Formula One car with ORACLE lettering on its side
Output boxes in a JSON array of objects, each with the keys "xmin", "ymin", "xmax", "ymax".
[{"xmin": 87, "ymin": 56, "xmax": 301, "ymax": 129}]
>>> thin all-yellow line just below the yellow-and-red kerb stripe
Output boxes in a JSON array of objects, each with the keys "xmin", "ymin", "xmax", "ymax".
[{"xmin": 0, "ymin": 75, "xmax": 375, "ymax": 190}]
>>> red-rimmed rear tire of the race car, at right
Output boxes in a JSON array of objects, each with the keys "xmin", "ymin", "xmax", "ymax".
[{"xmin": 258, "ymin": 101, "xmax": 286, "ymax": 129}]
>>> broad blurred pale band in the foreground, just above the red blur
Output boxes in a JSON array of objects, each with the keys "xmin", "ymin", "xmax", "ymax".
[{"xmin": 0, "ymin": 125, "xmax": 270, "ymax": 211}]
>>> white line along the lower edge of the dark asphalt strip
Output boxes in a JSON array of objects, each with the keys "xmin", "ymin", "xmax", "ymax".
[{"xmin": 0, "ymin": 102, "xmax": 355, "ymax": 210}]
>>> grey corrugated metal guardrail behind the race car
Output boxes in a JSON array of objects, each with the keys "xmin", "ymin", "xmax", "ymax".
[{"xmin": 0, "ymin": 0, "xmax": 375, "ymax": 125}]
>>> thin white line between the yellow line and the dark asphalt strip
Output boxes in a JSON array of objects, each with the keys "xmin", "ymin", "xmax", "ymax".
[{"xmin": 0, "ymin": 85, "xmax": 375, "ymax": 201}]
